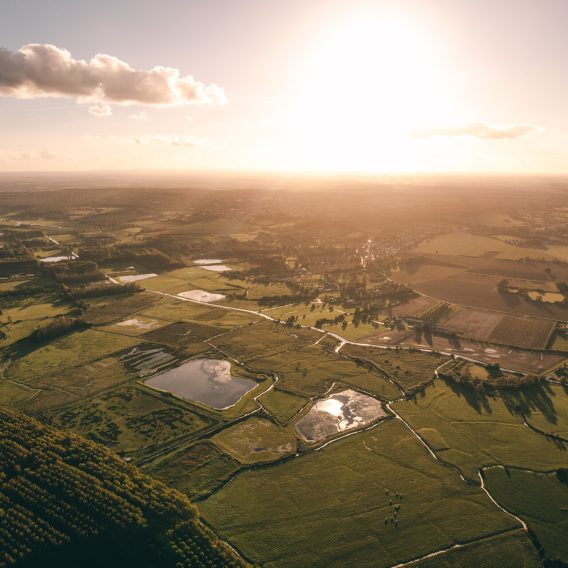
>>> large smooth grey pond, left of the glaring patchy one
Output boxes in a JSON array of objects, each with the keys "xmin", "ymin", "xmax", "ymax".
[{"xmin": 145, "ymin": 359, "xmax": 256, "ymax": 410}]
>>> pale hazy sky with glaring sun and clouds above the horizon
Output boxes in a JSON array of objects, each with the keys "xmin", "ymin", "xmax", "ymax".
[{"xmin": 0, "ymin": 0, "xmax": 568, "ymax": 174}]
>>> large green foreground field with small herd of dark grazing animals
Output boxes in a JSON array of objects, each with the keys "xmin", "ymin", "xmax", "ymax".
[{"xmin": 200, "ymin": 420, "xmax": 518, "ymax": 567}]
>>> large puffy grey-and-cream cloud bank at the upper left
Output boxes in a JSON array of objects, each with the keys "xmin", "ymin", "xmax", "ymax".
[{"xmin": 0, "ymin": 44, "xmax": 227, "ymax": 112}]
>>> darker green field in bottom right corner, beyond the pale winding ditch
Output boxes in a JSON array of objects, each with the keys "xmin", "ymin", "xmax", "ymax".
[{"xmin": 485, "ymin": 467, "xmax": 568, "ymax": 563}]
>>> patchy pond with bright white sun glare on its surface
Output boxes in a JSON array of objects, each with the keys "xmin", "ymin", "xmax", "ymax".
[{"xmin": 296, "ymin": 389, "xmax": 386, "ymax": 443}]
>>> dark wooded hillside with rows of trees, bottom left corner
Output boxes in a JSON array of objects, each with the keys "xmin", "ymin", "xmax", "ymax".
[{"xmin": 0, "ymin": 410, "xmax": 243, "ymax": 568}]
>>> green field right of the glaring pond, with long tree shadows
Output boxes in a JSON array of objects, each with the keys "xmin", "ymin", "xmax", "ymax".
[{"xmin": 392, "ymin": 380, "xmax": 568, "ymax": 480}]
